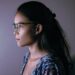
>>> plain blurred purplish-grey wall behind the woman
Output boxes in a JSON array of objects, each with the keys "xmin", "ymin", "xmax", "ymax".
[{"xmin": 0, "ymin": 0, "xmax": 75, "ymax": 75}]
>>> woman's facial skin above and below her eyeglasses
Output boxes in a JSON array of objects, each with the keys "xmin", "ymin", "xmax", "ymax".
[{"xmin": 14, "ymin": 13, "xmax": 32, "ymax": 47}]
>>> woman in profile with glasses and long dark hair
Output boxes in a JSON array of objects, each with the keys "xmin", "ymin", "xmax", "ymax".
[{"xmin": 14, "ymin": 1, "xmax": 71, "ymax": 75}]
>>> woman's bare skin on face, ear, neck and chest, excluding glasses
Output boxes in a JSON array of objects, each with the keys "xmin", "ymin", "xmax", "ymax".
[{"xmin": 14, "ymin": 13, "xmax": 47, "ymax": 75}]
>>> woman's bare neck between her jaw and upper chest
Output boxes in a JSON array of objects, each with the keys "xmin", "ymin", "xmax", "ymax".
[{"xmin": 28, "ymin": 43, "xmax": 47, "ymax": 58}]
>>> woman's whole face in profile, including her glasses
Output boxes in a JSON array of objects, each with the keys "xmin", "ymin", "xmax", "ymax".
[{"xmin": 14, "ymin": 13, "xmax": 33, "ymax": 47}]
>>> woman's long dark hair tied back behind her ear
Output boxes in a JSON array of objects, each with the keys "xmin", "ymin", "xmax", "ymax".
[{"xmin": 17, "ymin": 1, "xmax": 71, "ymax": 73}]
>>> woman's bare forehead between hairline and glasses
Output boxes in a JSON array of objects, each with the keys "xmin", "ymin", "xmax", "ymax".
[{"xmin": 14, "ymin": 13, "xmax": 30, "ymax": 23}]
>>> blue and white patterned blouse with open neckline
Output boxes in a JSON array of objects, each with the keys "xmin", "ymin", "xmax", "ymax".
[{"xmin": 20, "ymin": 53, "xmax": 66, "ymax": 75}]
